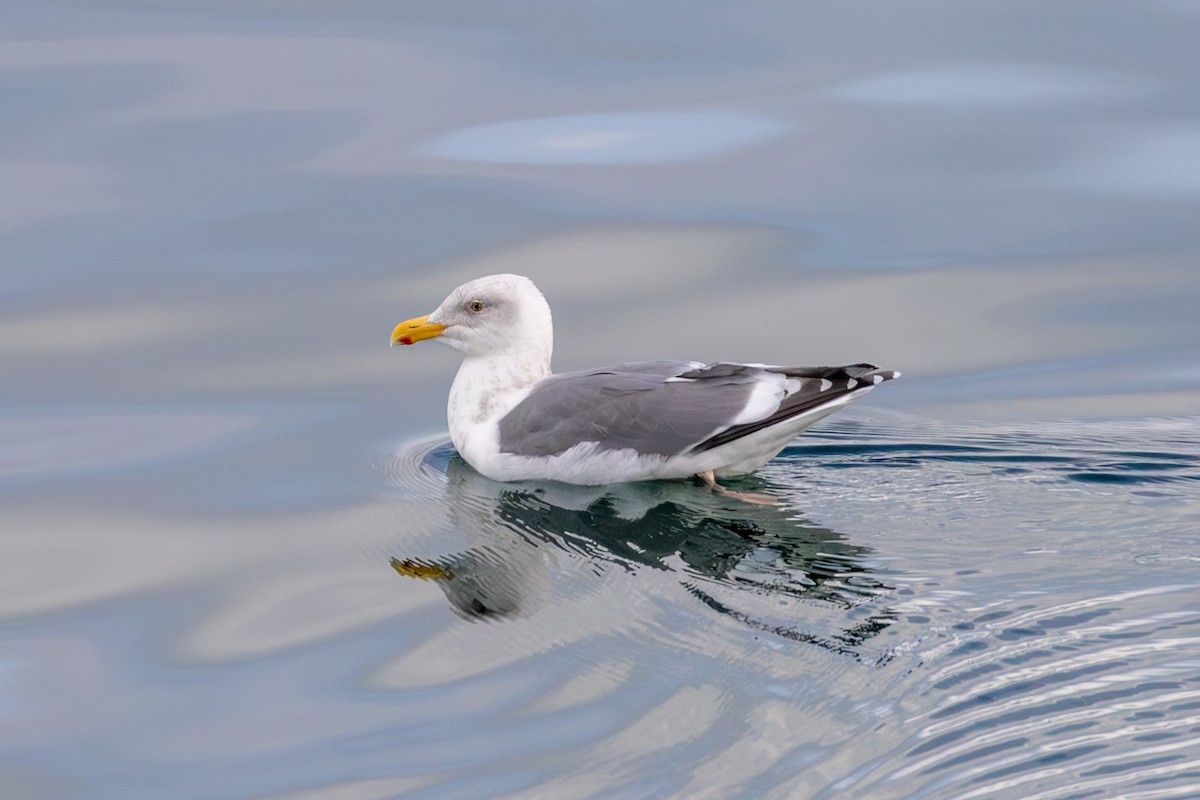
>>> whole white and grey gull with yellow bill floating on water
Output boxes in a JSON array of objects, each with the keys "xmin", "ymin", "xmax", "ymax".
[{"xmin": 391, "ymin": 275, "xmax": 900, "ymax": 499}]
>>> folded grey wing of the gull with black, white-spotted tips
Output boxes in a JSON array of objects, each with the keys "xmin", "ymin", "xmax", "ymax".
[{"xmin": 499, "ymin": 361, "xmax": 897, "ymax": 456}]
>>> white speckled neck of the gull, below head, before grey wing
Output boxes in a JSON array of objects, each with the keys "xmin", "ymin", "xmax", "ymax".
[{"xmin": 446, "ymin": 353, "xmax": 550, "ymax": 450}]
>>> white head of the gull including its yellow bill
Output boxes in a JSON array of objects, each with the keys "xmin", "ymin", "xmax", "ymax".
[{"xmin": 391, "ymin": 275, "xmax": 554, "ymax": 369}]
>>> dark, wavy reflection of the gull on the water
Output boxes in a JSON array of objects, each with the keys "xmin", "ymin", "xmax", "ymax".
[{"xmin": 391, "ymin": 456, "xmax": 895, "ymax": 657}]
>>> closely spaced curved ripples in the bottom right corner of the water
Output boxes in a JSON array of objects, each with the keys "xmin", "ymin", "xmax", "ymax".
[{"xmin": 840, "ymin": 584, "xmax": 1200, "ymax": 799}]
